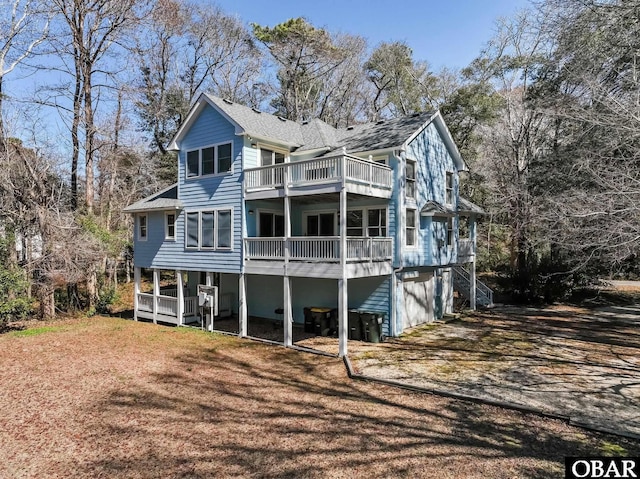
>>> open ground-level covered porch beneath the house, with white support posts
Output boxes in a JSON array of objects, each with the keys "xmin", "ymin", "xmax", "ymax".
[{"xmin": 134, "ymin": 268, "xmax": 393, "ymax": 355}]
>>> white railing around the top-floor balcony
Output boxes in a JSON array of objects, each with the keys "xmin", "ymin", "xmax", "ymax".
[{"xmin": 245, "ymin": 156, "xmax": 393, "ymax": 191}]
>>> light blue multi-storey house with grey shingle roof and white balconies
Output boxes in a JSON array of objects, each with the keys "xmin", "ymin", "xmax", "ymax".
[{"xmin": 125, "ymin": 94, "xmax": 490, "ymax": 355}]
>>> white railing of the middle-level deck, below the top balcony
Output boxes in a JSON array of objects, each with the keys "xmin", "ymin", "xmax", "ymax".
[{"xmin": 245, "ymin": 236, "xmax": 393, "ymax": 263}]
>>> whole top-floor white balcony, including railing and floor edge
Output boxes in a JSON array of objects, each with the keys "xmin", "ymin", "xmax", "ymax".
[{"xmin": 244, "ymin": 155, "xmax": 393, "ymax": 199}]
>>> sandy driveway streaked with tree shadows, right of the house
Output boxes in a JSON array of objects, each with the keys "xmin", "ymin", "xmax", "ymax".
[{"xmin": 350, "ymin": 305, "xmax": 640, "ymax": 436}]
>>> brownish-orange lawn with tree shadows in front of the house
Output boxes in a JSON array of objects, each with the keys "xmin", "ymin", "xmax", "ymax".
[{"xmin": 0, "ymin": 317, "xmax": 640, "ymax": 478}]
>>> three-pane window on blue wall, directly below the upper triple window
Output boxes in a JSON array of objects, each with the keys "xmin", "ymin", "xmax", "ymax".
[{"xmin": 185, "ymin": 210, "xmax": 232, "ymax": 250}]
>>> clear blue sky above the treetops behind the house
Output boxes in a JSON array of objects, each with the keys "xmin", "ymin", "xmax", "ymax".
[{"xmin": 210, "ymin": 0, "xmax": 529, "ymax": 70}]
